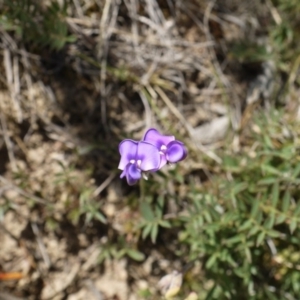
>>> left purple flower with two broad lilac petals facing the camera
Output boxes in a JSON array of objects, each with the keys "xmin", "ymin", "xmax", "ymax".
[{"xmin": 118, "ymin": 140, "xmax": 161, "ymax": 185}]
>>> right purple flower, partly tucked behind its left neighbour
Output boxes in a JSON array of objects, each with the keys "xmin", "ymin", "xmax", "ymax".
[{"xmin": 143, "ymin": 128, "xmax": 187, "ymax": 169}]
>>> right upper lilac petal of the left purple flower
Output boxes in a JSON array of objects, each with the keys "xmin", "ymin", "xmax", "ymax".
[{"xmin": 137, "ymin": 141, "xmax": 161, "ymax": 171}]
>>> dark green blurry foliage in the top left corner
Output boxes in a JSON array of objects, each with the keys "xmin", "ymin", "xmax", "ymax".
[{"xmin": 0, "ymin": 0, "xmax": 76, "ymax": 50}]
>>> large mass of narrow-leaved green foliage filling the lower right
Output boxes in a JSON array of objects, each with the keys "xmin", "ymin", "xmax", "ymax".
[{"xmin": 179, "ymin": 111, "xmax": 300, "ymax": 299}]
